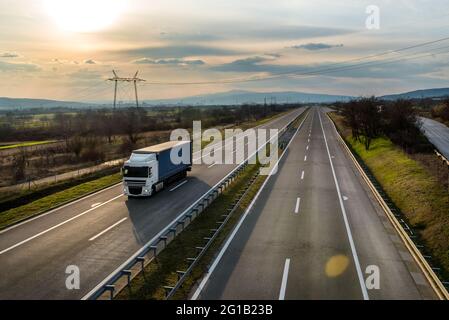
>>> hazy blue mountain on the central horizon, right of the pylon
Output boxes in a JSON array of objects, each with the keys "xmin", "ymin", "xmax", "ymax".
[{"xmin": 144, "ymin": 91, "xmax": 352, "ymax": 105}]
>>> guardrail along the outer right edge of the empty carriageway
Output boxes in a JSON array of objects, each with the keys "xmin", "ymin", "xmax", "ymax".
[{"xmin": 327, "ymin": 115, "xmax": 449, "ymax": 300}]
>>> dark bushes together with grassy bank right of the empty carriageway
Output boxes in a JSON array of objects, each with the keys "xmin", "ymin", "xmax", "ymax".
[{"xmin": 331, "ymin": 98, "xmax": 449, "ymax": 278}]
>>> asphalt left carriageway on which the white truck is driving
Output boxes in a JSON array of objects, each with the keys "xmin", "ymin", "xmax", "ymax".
[{"xmin": 0, "ymin": 109, "xmax": 304, "ymax": 300}]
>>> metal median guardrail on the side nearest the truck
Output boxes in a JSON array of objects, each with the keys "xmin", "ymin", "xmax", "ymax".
[{"xmin": 82, "ymin": 110, "xmax": 307, "ymax": 300}]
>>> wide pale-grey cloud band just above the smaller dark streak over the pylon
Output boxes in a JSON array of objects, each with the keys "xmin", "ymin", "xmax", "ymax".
[{"xmin": 112, "ymin": 45, "xmax": 242, "ymax": 59}]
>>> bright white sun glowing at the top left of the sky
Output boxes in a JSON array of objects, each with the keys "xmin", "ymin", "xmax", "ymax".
[{"xmin": 45, "ymin": 0, "xmax": 125, "ymax": 32}]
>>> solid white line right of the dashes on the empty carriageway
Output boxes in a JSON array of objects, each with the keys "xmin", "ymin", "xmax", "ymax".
[{"xmin": 318, "ymin": 111, "xmax": 369, "ymax": 300}]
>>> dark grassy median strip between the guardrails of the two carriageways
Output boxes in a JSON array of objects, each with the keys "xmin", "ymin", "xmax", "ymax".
[{"xmin": 116, "ymin": 165, "xmax": 266, "ymax": 300}]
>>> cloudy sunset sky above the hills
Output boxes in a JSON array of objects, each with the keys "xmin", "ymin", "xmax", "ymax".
[{"xmin": 0, "ymin": 0, "xmax": 449, "ymax": 101}]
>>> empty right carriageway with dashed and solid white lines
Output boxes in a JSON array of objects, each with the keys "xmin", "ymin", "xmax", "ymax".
[{"xmin": 191, "ymin": 108, "xmax": 436, "ymax": 300}]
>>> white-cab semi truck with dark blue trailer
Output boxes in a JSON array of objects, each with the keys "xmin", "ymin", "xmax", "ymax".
[{"xmin": 122, "ymin": 141, "xmax": 192, "ymax": 197}]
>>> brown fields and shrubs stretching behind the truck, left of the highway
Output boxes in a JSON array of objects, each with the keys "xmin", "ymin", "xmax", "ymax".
[{"xmin": 0, "ymin": 105, "xmax": 296, "ymax": 188}]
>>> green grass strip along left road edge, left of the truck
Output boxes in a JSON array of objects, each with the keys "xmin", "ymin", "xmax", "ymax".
[{"xmin": 0, "ymin": 173, "xmax": 122, "ymax": 229}]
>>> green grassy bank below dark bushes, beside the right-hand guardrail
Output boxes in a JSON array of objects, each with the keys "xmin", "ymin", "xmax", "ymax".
[{"xmin": 332, "ymin": 114, "xmax": 449, "ymax": 276}]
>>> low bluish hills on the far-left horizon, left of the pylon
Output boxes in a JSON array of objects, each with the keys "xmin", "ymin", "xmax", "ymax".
[{"xmin": 0, "ymin": 97, "xmax": 93, "ymax": 109}]
